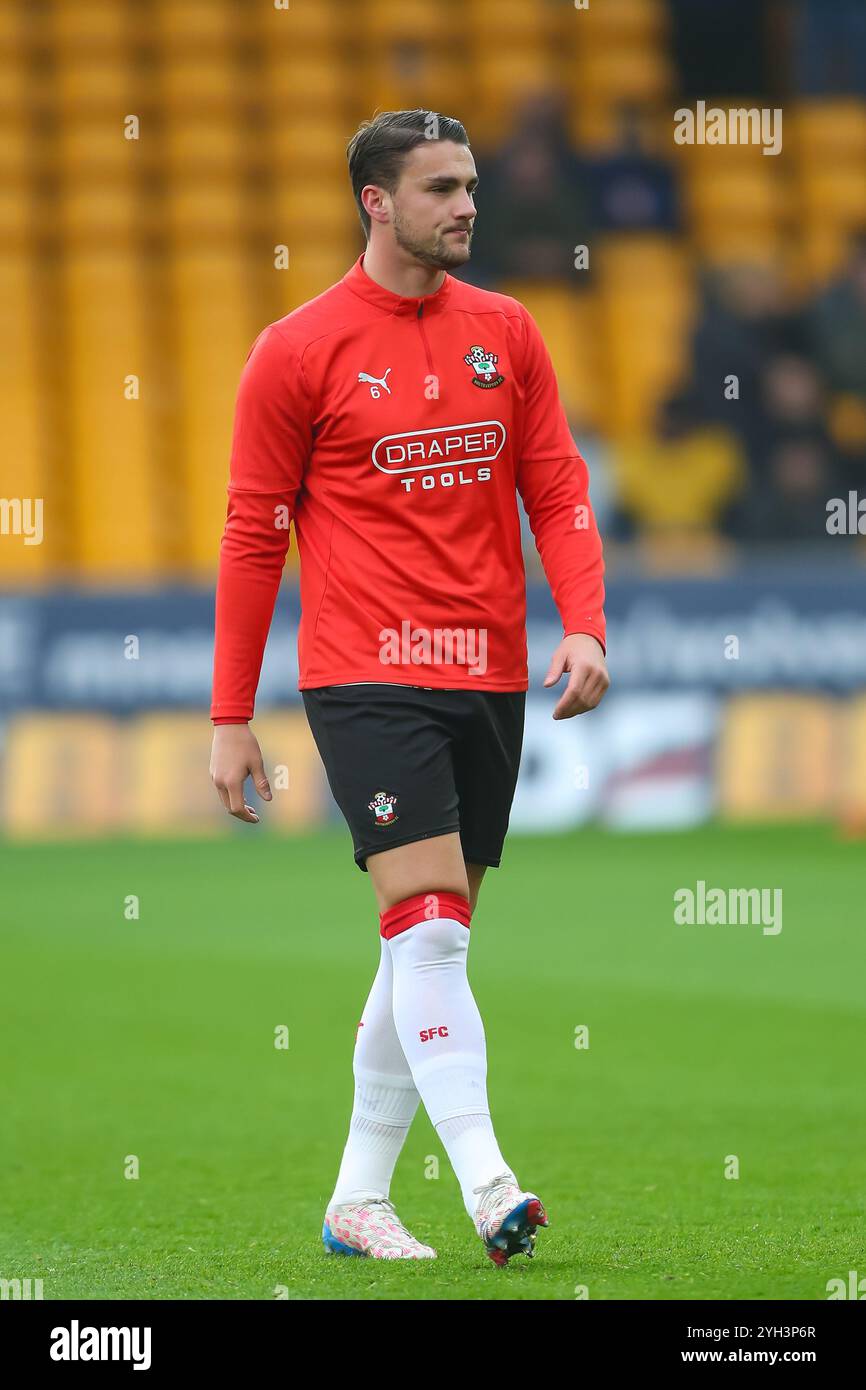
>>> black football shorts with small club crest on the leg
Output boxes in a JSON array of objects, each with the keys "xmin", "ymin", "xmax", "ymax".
[{"xmin": 302, "ymin": 684, "xmax": 525, "ymax": 870}]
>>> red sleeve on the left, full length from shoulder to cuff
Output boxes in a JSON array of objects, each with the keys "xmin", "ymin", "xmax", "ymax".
[{"xmin": 210, "ymin": 324, "xmax": 313, "ymax": 723}]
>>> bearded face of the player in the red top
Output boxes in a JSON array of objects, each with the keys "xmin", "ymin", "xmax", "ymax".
[{"xmin": 391, "ymin": 140, "xmax": 478, "ymax": 270}]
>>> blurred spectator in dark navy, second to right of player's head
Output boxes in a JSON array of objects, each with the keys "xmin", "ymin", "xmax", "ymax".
[{"xmin": 588, "ymin": 103, "xmax": 680, "ymax": 232}]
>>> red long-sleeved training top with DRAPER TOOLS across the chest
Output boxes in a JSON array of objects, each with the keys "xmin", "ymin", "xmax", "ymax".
[{"xmin": 211, "ymin": 256, "xmax": 605, "ymax": 723}]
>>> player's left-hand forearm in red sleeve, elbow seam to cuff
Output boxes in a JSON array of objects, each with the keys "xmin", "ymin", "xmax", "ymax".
[{"xmin": 210, "ymin": 491, "xmax": 289, "ymax": 723}]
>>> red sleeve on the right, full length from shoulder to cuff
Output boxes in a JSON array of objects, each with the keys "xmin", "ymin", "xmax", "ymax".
[{"xmin": 517, "ymin": 309, "xmax": 606, "ymax": 648}]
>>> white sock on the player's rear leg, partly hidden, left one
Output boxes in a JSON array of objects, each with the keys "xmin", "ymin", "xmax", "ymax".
[{"xmin": 328, "ymin": 938, "xmax": 421, "ymax": 1207}]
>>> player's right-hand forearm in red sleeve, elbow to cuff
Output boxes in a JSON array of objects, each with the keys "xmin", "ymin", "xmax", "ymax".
[{"xmin": 521, "ymin": 456, "xmax": 606, "ymax": 648}]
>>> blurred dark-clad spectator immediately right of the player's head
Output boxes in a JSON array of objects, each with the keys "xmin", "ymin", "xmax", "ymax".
[{"xmin": 467, "ymin": 93, "xmax": 589, "ymax": 288}]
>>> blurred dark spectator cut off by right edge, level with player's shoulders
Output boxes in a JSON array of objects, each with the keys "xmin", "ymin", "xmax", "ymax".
[{"xmin": 809, "ymin": 230, "xmax": 866, "ymax": 400}]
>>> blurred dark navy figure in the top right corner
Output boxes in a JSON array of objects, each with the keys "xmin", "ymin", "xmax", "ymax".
[{"xmin": 794, "ymin": 0, "xmax": 866, "ymax": 96}]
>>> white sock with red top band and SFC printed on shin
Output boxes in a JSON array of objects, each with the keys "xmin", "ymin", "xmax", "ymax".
[{"xmin": 382, "ymin": 892, "xmax": 513, "ymax": 1216}]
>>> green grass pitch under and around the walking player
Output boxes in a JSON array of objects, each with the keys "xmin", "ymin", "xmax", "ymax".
[{"xmin": 0, "ymin": 809, "xmax": 866, "ymax": 1300}]
